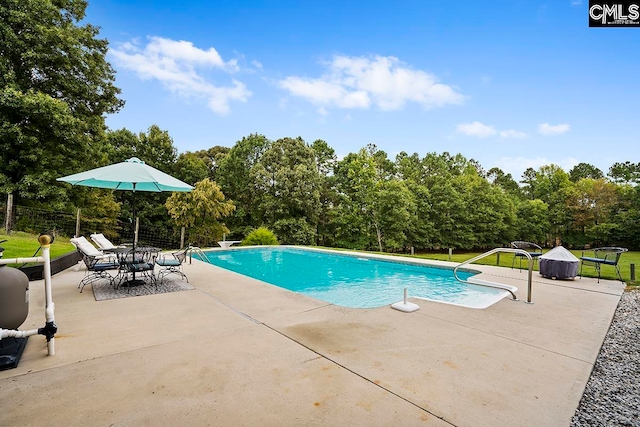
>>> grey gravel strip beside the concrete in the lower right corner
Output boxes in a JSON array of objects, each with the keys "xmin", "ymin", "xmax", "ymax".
[{"xmin": 571, "ymin": 289, "xmax": 640, "ymax": 427}]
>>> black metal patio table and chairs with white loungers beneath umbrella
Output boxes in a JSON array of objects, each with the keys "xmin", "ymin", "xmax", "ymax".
[{"xmin": 71, "ymin": 234, "xmax": 189, "ymax": 292}]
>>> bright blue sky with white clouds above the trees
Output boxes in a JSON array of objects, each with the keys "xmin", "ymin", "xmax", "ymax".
[{"xmin": 86, "ymin": 0, "xmax": 640, "ymax": 180}]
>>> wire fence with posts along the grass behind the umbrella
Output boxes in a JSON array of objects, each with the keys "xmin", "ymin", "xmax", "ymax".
[{"xmin": 0, "ymin": 205, "xmax": 200, "ymax": 249}]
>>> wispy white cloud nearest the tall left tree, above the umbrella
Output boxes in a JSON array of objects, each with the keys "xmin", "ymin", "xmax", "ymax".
[{"xmin": 109, "ymin": 37, "xmax": 251, "ymax": 114}]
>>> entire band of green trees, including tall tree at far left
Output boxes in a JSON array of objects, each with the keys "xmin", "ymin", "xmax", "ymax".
[{"xmin": 0, "ymin": 0, "xmax": 640, "ymax": 251}]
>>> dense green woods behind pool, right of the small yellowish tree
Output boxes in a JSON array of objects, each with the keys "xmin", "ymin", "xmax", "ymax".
[{"xmin": 171, "ymin": 134, "xmax": 640, "ymax": 251}]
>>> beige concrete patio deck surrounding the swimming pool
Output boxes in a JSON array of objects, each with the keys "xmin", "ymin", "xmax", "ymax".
[{"xmin": 0, "ymin": 251, "xmax": 624, "ymax": 426}]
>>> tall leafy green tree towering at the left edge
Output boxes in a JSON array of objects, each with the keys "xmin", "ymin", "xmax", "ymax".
[{"xmin": 0, "ymin": 0, "xmax": 123, "ymax": 203}]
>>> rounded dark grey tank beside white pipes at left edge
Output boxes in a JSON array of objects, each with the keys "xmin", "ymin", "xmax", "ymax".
[{"xmin": 0, "ymin": 248, "xmax": 29, "ymax": 329}]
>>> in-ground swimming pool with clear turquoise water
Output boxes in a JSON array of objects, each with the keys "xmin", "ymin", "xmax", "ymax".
[{"xmin": 199, "ymin": 246, "xmax": 507, "ymax": 308}]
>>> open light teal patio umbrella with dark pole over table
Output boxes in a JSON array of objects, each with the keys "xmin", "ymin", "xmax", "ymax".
[{"xmin": 58, "ymin": 157, "xmax": 193, "ymax": 281}]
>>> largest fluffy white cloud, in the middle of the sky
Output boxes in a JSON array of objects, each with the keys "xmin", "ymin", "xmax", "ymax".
[{"xmin": 278, "ymin": 56, "xmax": 464, "ymax": 111}]
